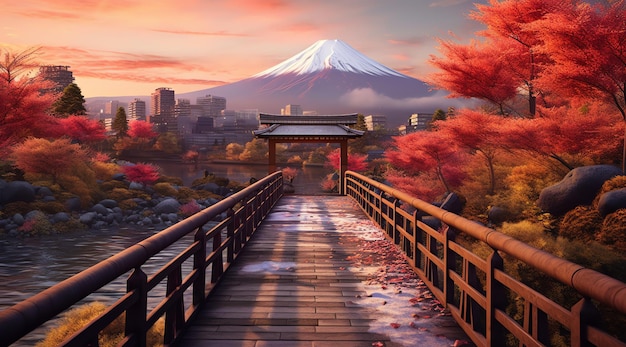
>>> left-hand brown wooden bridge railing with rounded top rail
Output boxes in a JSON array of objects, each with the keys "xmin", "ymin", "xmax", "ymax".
[{"xmin": 0, "ymin": 172, "xmax": 283, "ymax": 346}]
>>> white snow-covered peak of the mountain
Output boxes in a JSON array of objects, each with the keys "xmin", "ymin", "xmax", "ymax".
[{"xmin": 252, "ymin": 40, "xmax": 408, "ymax": 78}]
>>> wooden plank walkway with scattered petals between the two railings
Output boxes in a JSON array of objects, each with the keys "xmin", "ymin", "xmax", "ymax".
[{"xmin": 180, "ymin": 196, "xmax": 468, "ymax": 347}]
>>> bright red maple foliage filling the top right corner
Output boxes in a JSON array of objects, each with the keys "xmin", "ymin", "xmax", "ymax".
[{"xmin": 530, "ymin": 0, "xmax": 626, "ymax": 120}]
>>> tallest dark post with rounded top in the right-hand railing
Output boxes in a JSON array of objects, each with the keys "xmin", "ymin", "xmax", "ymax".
[{"xmin": 485, "ymin": 250, "xmax": 507, "ymax": 346}]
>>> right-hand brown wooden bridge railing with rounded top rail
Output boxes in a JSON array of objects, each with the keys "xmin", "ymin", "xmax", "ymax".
[{"xmin": 345, "ymin": 171, "xmax": 626, "ymax": 346}]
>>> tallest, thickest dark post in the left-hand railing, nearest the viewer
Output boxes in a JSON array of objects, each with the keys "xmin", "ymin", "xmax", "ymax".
[{"xmin": 124, "ymin": 267, "xmax": 148, "ymax": 347}]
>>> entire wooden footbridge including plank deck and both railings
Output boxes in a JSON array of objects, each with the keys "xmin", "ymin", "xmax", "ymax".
[{"xmin": 0, "ymin": 172, "xmax": 626, "ymax": 346}]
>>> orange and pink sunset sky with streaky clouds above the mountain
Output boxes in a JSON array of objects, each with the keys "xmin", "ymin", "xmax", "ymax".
[{"xmin": 0, "ymin": 0, "xmax": 487, "ymax": 97}]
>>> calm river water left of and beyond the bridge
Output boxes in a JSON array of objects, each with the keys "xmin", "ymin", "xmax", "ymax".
[{"xmin": 0, "ymin": 162, "xmax": 329, "ymax": 346}]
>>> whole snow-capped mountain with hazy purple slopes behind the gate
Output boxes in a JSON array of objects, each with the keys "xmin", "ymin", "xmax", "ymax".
[{"xmin": 92, "ymin": 40, "xmax": 466, "ymax": 127}]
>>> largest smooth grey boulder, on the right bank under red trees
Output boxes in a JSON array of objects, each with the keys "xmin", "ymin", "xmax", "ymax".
[{"xmin": 537, "ymin": 165, "xmax": 623, "ymax": 216}]
